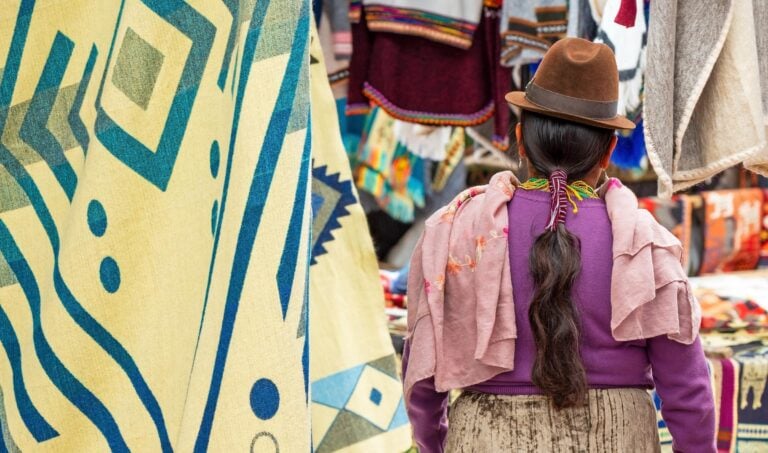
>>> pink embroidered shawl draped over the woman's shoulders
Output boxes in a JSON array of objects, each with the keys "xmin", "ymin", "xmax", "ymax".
[{"xmin": 404, "ymin": 172, "xmax": 701, "ymax": 399}]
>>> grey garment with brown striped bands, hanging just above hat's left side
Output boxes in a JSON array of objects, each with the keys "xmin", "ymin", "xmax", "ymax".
[{"xmin": 500, "ymin": 0, "xmax": 568, "ymax": 67}]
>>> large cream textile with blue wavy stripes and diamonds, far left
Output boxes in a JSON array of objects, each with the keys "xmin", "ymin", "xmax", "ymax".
[{"xmin": 0, "ymin": 0, "xmax": 312, "ymax": 452}]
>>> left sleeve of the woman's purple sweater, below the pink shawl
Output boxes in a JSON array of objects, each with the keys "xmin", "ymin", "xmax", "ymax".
[{"xmin": 403, "ymin": 340, "xmax": 448, "ymax": 453}]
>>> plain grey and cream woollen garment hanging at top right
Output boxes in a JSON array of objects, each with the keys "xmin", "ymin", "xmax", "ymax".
[{"xmin": 644, "ymin": 0, "xmax": 768, "ymax": 198}]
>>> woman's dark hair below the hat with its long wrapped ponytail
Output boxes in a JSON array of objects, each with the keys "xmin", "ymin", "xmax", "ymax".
[{"xmin": 521, "ymin": 112, "xmax": 613, "ymax": 409}]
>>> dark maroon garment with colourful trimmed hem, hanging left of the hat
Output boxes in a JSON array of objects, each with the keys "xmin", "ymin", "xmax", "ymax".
[{"xmin": 347, "ymin": 7, "xmax": 511, "ymax": 148}]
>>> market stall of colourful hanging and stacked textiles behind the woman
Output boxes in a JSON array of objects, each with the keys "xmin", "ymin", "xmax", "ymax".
[{"xmin": 318, "ymin": 0, "xmax": 768, "ymax": 451}]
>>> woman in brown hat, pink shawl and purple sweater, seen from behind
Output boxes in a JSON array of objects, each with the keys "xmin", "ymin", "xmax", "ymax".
[{"xmin": 403, "ymin": 38, "xmax": 715, "ymax": 452}]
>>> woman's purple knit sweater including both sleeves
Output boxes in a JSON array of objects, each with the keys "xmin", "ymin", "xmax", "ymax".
[{"xmin": 403, "ymin": 190, "xmax": 715, "ymax": 453}]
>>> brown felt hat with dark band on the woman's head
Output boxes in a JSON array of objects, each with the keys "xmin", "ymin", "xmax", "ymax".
[{"xmin": 505, "ymin": 38, "xmax": 635, "ymax": 129}]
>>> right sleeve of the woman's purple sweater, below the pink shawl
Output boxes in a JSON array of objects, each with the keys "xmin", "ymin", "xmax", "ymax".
[{"xmin": 648, "ymin": 336, "xmax": 715, "ymax": 453}]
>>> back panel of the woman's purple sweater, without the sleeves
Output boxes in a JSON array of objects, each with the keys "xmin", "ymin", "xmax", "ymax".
[{"xmin": 473, "ymin": 190, "xmax": 653, "ymax": 394}]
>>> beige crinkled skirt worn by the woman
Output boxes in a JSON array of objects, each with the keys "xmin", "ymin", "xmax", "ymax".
[{"xmin": 445, "ymin": 389, "xmax": 660, "ymax": 453}]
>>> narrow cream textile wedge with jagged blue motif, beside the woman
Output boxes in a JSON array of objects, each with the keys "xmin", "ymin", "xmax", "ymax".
[{"xmin": 309, "ymin": 28, "xmax": 411, "ymax": 453}]
